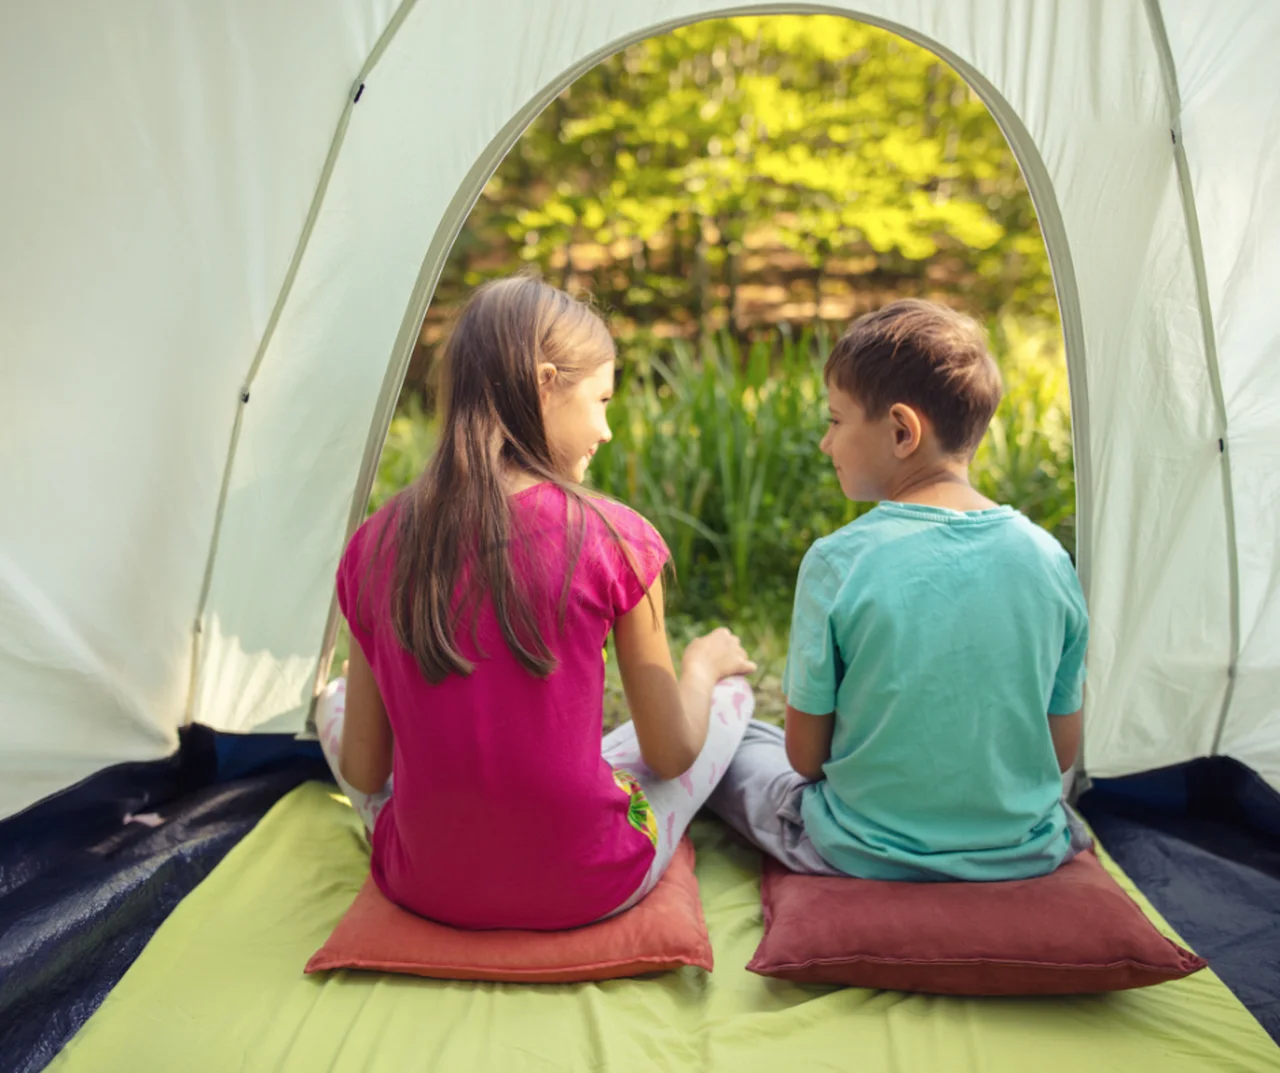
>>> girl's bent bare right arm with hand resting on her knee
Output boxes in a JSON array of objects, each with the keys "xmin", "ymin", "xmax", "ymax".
[{"xmin": 613, "ymin": 576, "xmax": 755, "ymax": 779}]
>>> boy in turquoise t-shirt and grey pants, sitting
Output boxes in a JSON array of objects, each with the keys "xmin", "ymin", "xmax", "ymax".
[{"xmin": 708, "ymin": 300, "xmax": 1089, "ymax": 881}]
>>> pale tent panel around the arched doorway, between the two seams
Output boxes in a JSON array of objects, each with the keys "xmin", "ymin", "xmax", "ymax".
[{"xmin": 197, "ymin": 0, "xmax": 1230, "ymax": 775}]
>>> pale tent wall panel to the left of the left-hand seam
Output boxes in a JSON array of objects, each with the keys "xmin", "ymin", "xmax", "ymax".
[{"xmin": 0, "ymin": 0, "xmax": 393, "ymax": 816}]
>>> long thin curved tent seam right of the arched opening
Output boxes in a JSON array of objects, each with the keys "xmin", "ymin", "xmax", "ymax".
[{"xmin": 1144, "ymin": 0, "xmax": 1240, "ymax": 755}]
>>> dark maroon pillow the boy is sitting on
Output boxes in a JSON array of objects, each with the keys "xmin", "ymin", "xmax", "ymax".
[{"xmin": 748, "ymin": 850, "xmax": 1206, "ymax": 995}]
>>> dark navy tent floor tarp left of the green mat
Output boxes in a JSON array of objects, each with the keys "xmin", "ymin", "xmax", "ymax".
[{"xmin": 0, "ymin": 726, "xmax": 329, "ymax": 1073}]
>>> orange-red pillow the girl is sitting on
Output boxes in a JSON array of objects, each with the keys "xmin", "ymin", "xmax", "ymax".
[{"xmin": 306, "ymin": 836, "xmax": 712, "ymax": 983}]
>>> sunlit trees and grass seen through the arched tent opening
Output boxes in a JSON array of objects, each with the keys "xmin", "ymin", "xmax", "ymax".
[{"xmin": 340, "ymin": 15, "xmax": 1075, "ymax": 716}]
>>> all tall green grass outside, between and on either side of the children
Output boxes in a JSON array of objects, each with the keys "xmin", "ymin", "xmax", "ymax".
[{"xmin": 370, "ymin": 320, "xmax": 1075, "ymax": 638}]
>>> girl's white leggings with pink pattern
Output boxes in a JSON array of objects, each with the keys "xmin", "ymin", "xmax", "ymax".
[{"xmin": 316, "ymin": 677, "xmax": 755, "ymax": 916}]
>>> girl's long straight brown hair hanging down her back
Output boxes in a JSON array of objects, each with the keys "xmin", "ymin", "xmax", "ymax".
[{"xmin": 366, "ymin": 277, "xmax": 635, "ymax": 682}]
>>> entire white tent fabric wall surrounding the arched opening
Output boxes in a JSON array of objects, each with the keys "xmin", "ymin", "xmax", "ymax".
[{"xmin": 0, "ymin": 0, "xmax": 1280, "ymax": 816}]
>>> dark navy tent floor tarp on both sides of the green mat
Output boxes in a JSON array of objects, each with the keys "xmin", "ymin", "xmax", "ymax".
[{"xmin": 0, "ymin": 727, "xmax": 1280, "ymax": 1073}]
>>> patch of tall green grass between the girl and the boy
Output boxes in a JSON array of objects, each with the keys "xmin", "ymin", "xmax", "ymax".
[{"xmin": 590, "ymin": 333, "xmax": 855, "ymax": 618}]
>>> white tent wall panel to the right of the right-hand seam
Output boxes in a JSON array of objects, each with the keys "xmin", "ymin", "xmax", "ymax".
[{"xmin": 1166, "ymin": 3, "xmax": 1280, "ymax": 787}]
